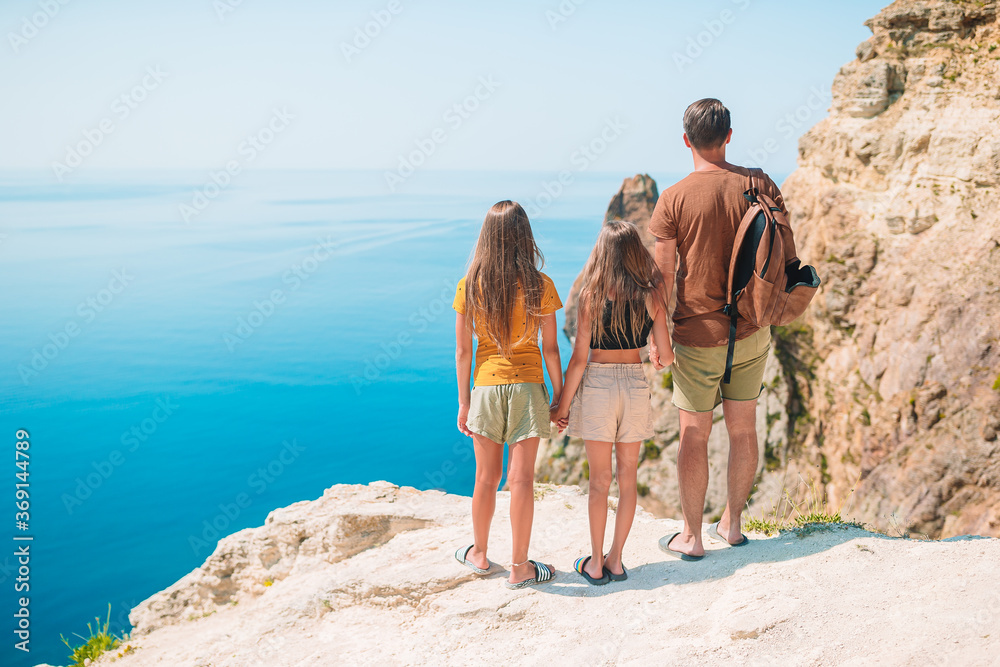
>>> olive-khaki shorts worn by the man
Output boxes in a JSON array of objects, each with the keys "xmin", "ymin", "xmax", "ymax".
[{"xmin": 671, "ymin": 327, "xmax": 771, "ymax": 412}]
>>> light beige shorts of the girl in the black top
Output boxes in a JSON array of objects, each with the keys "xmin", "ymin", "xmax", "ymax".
[{"xmin": 566, "ymin": 364, "xmax": 653, "ymax": 442}]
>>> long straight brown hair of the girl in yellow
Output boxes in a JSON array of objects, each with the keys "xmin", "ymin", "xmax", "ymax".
[{"xmin": 465, "ymin": 200, "xmax": 544, "ymax": 358}]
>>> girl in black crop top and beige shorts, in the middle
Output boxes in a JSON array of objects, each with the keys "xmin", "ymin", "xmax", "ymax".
[{"xmin": 552, "ymin": 220, "xmax": 673, "ymax": 585}]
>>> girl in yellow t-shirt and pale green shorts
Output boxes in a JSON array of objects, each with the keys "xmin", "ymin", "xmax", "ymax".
[{"xmin": 453, "ymin": 201, "xmax": 562, "ymax": 588}]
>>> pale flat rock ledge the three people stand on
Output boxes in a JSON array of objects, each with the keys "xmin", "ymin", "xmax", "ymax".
[{"xmin": 76, "ymin": 482, "xmax": 1000, "ymax": 667}]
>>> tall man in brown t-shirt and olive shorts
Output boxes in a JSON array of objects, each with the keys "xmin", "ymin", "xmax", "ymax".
[{"xmin": 649, "ymin": 98, "xmax": 788, "ymax": 560}]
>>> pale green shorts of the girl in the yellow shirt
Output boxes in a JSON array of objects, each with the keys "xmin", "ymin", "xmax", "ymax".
[{"xmin": 466, "ymin": 382, "xmax": 549, "ymax": 445}]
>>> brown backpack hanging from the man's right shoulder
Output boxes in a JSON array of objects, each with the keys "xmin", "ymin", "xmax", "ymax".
[{"xmin": 722, "ymin": 169, "xmax": 820, "ymax": 384}]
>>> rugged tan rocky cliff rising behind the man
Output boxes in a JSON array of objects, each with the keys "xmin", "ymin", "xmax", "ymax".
[{"xmin": 538, "ymin": 0, "xmax": 1000, "ymax": 537}]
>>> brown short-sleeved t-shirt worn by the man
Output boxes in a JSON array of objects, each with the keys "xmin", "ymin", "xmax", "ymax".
[{"xmin": 649, "ymin": 165, "xmax": 788, "ymax": 347}]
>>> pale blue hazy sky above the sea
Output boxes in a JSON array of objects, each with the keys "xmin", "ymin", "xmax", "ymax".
[{"xmin": 0, "ymin": 0, "xmax": 886, "ymax": 177}]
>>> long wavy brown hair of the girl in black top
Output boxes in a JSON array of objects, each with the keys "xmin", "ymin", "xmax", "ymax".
[{"xmin": 577, "ymin": 220, "xmax": 666, "ymax": 344}]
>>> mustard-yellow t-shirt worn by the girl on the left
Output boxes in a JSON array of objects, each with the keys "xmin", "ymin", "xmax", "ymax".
[{"xmin": 452, "ymin": 273, "xmax": 562, "ymax": 387}]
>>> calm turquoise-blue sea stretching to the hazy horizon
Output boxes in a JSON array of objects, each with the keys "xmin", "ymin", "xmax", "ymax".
[{"xmin": 0, "ymin": 169, "xmax": 788, "ymax": 667}]
